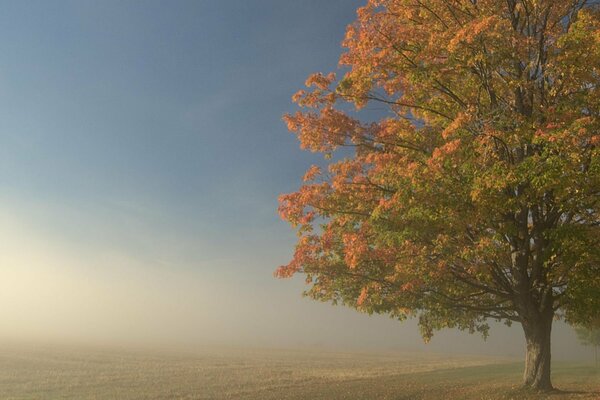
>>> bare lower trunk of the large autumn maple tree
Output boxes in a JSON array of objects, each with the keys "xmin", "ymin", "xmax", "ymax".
[{"xmin": 523, "ymin": 315, "xmax": 553, "ymax": 390}]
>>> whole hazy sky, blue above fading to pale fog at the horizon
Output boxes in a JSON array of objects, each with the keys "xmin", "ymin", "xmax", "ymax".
[{"xmin": 0, "ymin": 0, "xmax": 585, "ymax": 358}]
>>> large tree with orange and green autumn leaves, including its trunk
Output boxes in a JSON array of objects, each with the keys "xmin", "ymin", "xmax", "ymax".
[{"xmin": 276, "ymin": 0, "xmax": 600, "ymax": 390}]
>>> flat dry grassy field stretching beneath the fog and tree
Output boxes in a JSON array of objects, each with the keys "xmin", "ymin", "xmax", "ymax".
[{"xmin": 0, "ymin": 347, "xmax": 600, "ymax": 400}]
